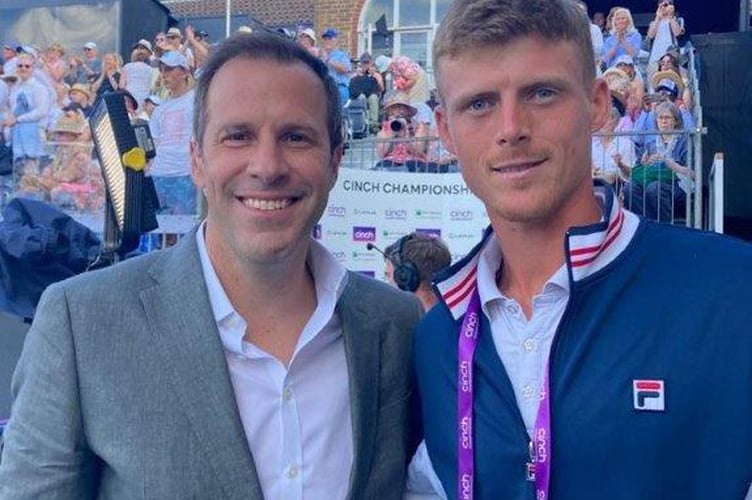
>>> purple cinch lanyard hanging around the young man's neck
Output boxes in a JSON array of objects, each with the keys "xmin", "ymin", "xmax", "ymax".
[{"xmin": 457, "ymin": 287, "xmax": 551, "ymax": 500}]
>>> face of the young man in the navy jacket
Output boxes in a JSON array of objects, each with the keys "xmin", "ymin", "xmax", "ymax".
[{"xmin": 436, "ymin": 37, "xmax": 610, "ymax": 228}]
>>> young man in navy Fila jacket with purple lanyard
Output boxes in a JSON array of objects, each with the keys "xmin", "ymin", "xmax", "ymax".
[{"xmin": 412, "ymin": 0, "xmax": 752, "ymax": 500}]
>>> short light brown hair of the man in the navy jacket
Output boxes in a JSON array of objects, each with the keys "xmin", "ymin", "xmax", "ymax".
[{"xmin": 433, "ymin": 0, "xmax": 595, "ymax": 88}]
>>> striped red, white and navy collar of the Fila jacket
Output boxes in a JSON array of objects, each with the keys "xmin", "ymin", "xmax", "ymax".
[{"xmin": 435, "ymin": 183, "xmax": 639, "ymax": 319}]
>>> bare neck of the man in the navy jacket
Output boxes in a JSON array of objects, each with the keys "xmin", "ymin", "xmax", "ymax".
[{"xmin": 492, "ymin": 184, "xmax": 602, "ymax": 318}]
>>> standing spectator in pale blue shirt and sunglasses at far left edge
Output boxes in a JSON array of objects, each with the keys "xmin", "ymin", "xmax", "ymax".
[{"xmin": 4, "ymin": 54, "xmax": 51, "ymax": 174}]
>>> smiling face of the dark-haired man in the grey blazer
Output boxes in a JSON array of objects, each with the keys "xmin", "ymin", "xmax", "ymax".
[{"xmin": 191, "ymin": 58, "xmax": 342, "ymax": 266}]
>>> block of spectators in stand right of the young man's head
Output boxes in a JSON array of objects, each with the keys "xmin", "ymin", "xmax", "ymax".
[{"xmin": 580, "ymin": 0, "xmax": 696, "ymax": 222}]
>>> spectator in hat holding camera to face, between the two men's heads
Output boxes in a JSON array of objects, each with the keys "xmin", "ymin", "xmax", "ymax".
[{"xmin": 374, "ymin": 91, "xmax": 429, "ymax": 172}]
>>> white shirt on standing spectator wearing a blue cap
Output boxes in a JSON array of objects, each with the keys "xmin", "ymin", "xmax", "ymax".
[{"xmin": 149, "ymin": 90, "xmax": 195, "ymax": 177}]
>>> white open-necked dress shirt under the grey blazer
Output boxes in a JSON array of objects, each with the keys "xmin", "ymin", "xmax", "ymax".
[{"xmin": 196, "ymin": 229, "xmax": 353, "ymax": 500}]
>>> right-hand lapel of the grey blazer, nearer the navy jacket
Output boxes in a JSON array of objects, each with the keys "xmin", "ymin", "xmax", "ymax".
[{"xmin": 337, "ymin": 273, "xmax": 380, "ymax": 498}]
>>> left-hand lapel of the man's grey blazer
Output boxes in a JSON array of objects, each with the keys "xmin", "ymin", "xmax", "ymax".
[{"xmin": 141, "ymin": 232, "xmax": 263, "ymax": 500}]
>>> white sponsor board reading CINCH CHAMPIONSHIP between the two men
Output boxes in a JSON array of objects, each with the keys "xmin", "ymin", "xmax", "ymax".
[{"xmin": 314, "ymin": 169, "xmax": 489, "ymax": 278}]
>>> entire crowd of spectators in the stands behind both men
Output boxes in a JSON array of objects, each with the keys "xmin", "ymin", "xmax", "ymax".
[{"xmin": 0, "ymin": 0, "xmax": 695, "ymax": 219}]
